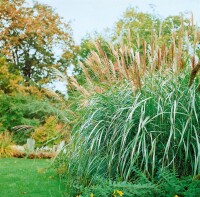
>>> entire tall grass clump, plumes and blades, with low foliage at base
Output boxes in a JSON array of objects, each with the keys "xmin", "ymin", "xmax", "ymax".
[{"xmin": 57, "ymin": 13, "xmax": 200, "ymax": 197}]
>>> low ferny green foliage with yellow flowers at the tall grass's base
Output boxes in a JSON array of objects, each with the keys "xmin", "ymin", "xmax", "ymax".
[{"xmin": 55, "ymin": 165, "xmax": 200, "ymax": 197}]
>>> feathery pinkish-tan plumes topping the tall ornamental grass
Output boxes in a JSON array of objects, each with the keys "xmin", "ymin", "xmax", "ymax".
[{"xmin": 69, "ymin": 14, "xmax": 200, "ymax": 96}]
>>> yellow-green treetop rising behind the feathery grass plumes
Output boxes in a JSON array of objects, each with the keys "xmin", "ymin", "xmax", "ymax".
[{"xmin": 112, "ymin": 8, "xmax": 193, "ymax": 48}]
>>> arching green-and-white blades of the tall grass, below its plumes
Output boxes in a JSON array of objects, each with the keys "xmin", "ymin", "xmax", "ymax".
[{"xmin": 56, "ymin": 70, "xmax": 200, "ymax": 194}]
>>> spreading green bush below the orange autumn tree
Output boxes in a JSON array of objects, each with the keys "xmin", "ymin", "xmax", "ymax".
[{"xmin": 0, "ymin": 94, "xmax": 66, "ymax": 144}]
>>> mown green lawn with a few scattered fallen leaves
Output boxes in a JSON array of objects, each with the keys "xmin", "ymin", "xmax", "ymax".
[{"xmin": 0, "ymin": 158, "xmax": 64, "ymax": 197}]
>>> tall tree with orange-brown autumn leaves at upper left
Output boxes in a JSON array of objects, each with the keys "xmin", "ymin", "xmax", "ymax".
[{"xmin": 0, "ymin": 0, "xmax": 76, "ymax": 84}]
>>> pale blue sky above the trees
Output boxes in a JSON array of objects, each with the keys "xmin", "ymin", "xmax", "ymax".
[{"xmin": 32, "ymin": 0, "xmax": 200, "ymax": 43}]
